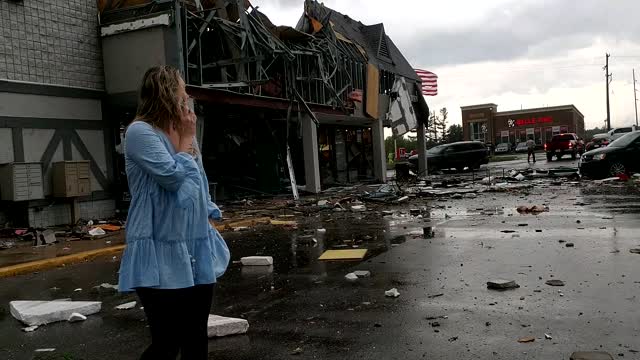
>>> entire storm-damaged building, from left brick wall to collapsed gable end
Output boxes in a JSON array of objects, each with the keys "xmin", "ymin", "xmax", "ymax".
[{"xmin": 0, "ymin": 0, "xmax": 429, "ymax": 227}]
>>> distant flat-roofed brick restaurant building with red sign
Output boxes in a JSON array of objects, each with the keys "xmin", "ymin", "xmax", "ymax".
[{"xmin": 460, "ymin": 104, "xmax": 584, "ymax": 146}]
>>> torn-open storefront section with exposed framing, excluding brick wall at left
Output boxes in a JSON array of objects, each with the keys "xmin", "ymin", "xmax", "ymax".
[{"xmin": 100, "ymin": 0, "xmax": 428, "ymax": 198}]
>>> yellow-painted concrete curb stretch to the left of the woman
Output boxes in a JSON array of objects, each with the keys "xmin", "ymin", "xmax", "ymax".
[{"xmin": 0, "ymin": 244, "xmax": 126, "ymax": 279}]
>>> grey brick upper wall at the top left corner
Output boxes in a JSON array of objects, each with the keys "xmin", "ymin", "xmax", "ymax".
[{"xmin": 0, "ymin": 0, "xmax": 104, "ymax": 90}]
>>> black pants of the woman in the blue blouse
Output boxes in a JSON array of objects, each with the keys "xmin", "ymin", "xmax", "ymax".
[{"xmin": 136, "ymin": 284, "xmax": 214, "ymax": 360}]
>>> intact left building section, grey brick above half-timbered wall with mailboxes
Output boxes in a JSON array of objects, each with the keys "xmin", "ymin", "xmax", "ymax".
[{"xmin": 0, "ymin": 0, "xmax": 116, "ymax": 227}]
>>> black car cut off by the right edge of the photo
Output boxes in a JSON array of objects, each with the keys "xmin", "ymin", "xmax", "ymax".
[{"xmin": 578, "ymin": 131, "xmax": 640, "ymax": 179}]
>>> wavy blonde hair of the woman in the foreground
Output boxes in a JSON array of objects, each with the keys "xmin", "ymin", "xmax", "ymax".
[{"xmin": 136, "ymin": 66, "xmax": 182, "ymax": 131}]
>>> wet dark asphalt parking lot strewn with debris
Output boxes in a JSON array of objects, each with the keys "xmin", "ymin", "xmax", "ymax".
[{"xmin": 0, "ymin": 161, "xmax": 640, "ymax": 360}]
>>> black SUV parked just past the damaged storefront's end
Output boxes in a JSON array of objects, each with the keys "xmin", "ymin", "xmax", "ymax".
[{"xmin": 409, "ymin": 141, "xmax": 489, "ymax": 171}]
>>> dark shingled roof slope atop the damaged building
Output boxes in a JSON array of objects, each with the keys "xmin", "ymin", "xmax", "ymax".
[{"xmin": 303, "ymin": 0, "xmax": 420, "ymax": 81}]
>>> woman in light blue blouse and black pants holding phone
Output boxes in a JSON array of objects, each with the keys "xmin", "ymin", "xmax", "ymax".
[{"xmin": 119, "ymin": 66, "xmax": 229, "ymax": 360}]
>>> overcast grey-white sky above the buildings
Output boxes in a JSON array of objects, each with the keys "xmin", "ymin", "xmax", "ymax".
[{"xmin": 251, "ymin": 0, "xmax": 640, "ymax": 134}]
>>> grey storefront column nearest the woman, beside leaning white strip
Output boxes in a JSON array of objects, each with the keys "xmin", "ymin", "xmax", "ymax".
[{"xmin": 300, "ymin": 114, "xmax": 320, "ymax": 194}]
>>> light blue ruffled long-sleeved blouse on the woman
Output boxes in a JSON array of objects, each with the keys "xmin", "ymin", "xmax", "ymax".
[{"xmin": 118, "ymin": 121, "xmax": 230, "ymax": 292}]
